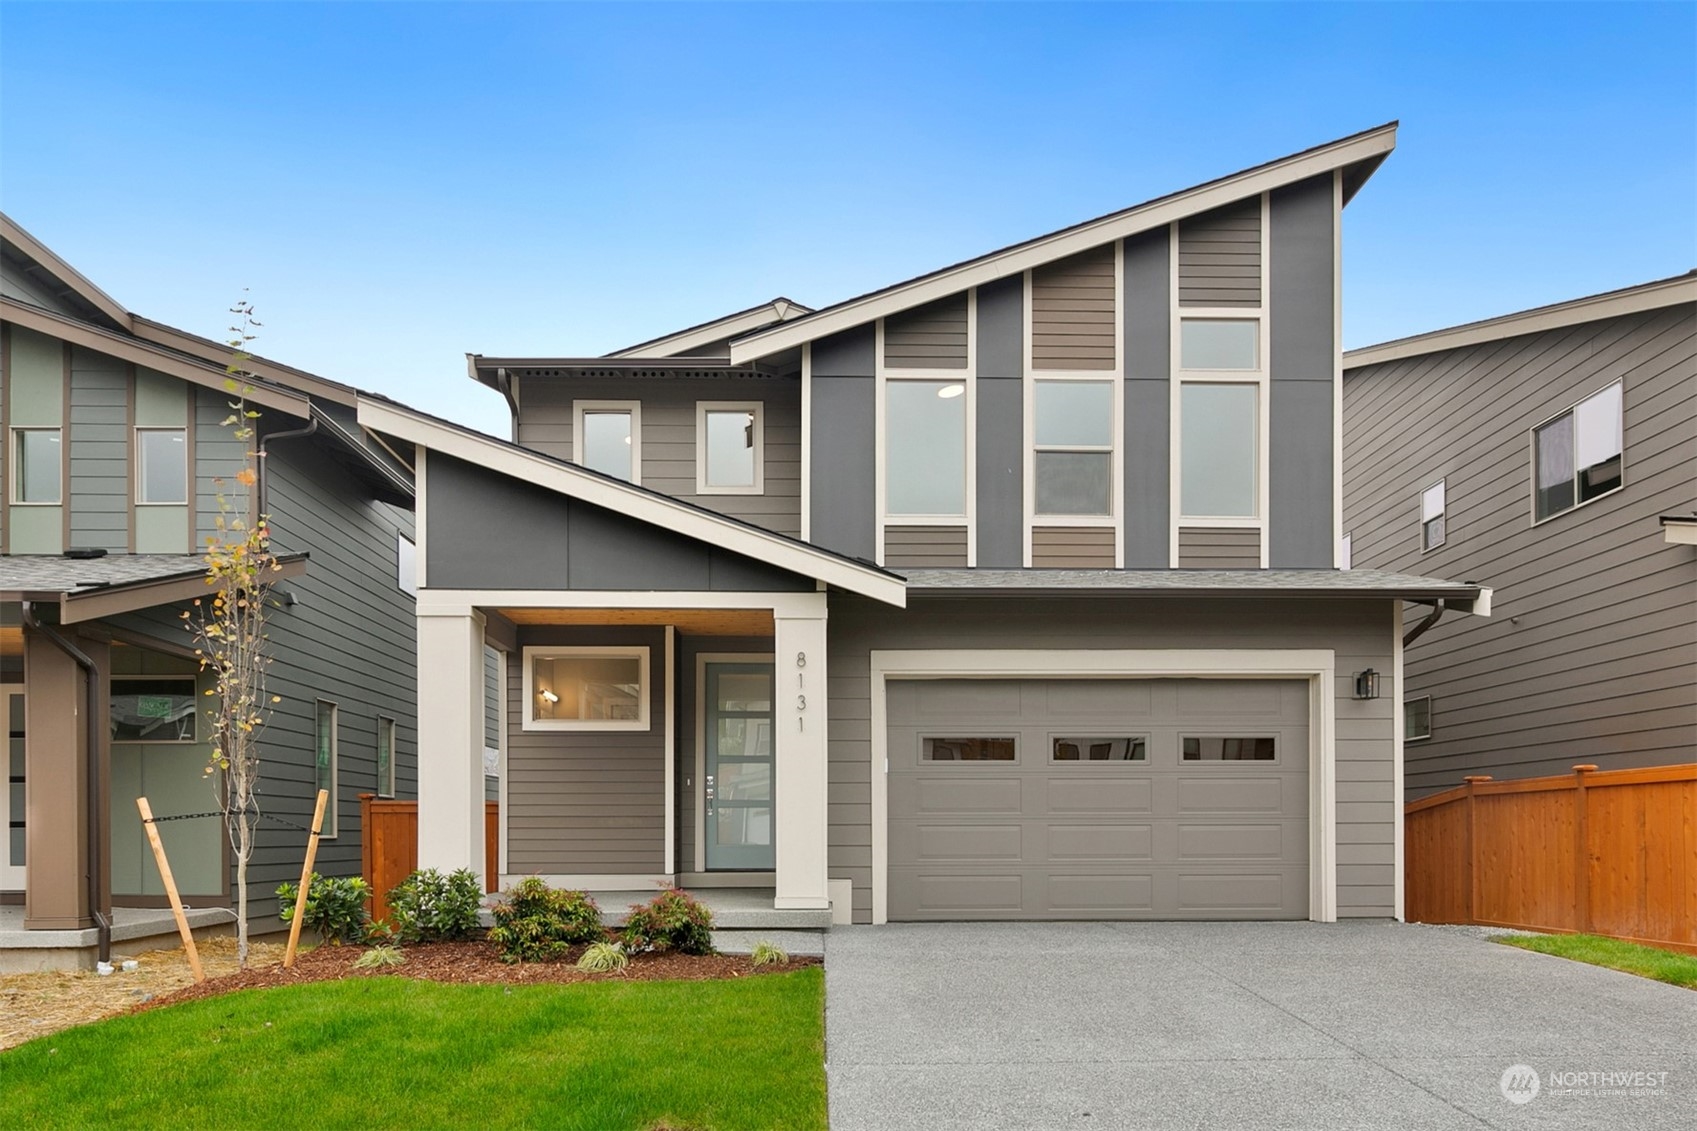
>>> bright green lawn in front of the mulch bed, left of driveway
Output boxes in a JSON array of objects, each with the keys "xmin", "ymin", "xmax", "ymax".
[{"xmin": 0, "ymin": 968, "xmax": 825, "ymax": 1131}]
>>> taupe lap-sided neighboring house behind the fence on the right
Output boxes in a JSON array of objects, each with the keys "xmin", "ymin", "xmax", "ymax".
[{"xmin": 1344, "ymin": 273, "xmax": 1697, "ymax": 795}]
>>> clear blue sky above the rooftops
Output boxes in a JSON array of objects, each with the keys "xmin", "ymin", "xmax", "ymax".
[{"xmin": 0, "ymin": 0, "xmax": 1697, "ymax": 433}]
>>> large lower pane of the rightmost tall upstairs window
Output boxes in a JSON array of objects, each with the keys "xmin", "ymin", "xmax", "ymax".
[{"xmin": 1179, "ymin": 382, "xmax": 1261, "ymax": 518}]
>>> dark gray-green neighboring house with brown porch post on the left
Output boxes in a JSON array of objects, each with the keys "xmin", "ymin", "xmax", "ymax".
[{"xmin": 0, "ymin": 217, "xmax": 417, "ymax": 957}]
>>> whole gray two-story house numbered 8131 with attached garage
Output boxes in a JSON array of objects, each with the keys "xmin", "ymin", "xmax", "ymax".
[{"xmin": 358, "ymin": 126, "xmax": 1488, "ymax": 922}]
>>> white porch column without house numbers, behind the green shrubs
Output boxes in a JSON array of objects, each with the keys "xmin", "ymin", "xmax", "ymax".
[{"xmin": 417, "ymin": 608, "xmax": 492, "ymax": 876}]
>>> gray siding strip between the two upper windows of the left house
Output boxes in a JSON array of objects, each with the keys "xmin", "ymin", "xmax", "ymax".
[{"xmin": 64, "ymin": 346, "xmax": 131, "ymax": 554}]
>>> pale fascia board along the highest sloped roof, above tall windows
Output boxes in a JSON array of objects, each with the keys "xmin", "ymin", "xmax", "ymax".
[{"xmin": 731, "ymin": 126, "xmax": 1397, "ymax": 363}]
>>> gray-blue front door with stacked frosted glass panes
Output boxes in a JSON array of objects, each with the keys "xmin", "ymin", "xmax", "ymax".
[{"xmin": 701, "ymin": 661, "xmax": 776, "ymax": 871}]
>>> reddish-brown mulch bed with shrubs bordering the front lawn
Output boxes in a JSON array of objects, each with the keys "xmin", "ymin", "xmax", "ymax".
[{"xmin": 131, "ymin": 941, "xmax": 820, "ymax": 1012}]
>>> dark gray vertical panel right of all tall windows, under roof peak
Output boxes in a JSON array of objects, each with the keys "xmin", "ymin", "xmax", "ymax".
[{"xmin": 1268, "ymin": 175, "xmax": 1337, "ymax": 569}]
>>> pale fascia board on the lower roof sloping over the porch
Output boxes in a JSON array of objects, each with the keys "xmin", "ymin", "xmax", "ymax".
[{"xmin": 360, "ymin": 397, "xmax": 908, "ymax": 608}]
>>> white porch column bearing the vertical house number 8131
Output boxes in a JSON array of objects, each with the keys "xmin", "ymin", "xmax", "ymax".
[{"xmin": 772, "ymin": 593, "xmax": 832, "ymax": 910}]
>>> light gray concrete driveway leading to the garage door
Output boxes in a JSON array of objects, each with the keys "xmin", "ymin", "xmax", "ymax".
[{"xmin": 825, "ymin": 922, "xmax": 1697, "ymax": 1131}]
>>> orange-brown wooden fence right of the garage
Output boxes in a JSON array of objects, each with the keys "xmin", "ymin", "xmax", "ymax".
[{"xmin": 1403, "ymin": 764, "xmax": 1697, "ymax": 953}]
